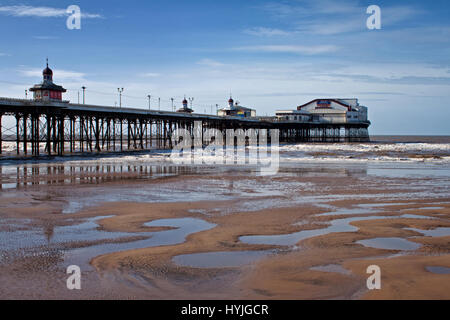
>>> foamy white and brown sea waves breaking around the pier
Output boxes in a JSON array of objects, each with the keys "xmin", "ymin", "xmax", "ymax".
[{"xmin": 0, "ymin": 136, "xmax": 450, "ymax": 166}]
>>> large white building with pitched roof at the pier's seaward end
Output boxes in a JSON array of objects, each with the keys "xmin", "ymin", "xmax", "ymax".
[{"xmin": 276, "ymin": 99, "xmax": 368, "ymax": 123}]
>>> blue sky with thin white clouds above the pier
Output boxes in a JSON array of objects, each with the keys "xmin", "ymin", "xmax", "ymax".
[{"xmin": 0, "ymin": 0, "xmax": 450, "ymax": 135}]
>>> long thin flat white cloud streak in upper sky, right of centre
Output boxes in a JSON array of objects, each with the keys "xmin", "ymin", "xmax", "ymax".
[{"xmin": 233, "ymin": 45, "xmax": 339, "ymax": 55}]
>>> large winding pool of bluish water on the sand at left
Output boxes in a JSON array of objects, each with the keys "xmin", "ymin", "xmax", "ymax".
[{"xmin": 0, "ymin": 216, "xmax": 215, "ymax": 270}]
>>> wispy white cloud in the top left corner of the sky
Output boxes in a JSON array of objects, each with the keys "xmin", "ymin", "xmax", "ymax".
[{"xmin": 0, "ymin": 5, "xmax": 102, "ymax": 18}]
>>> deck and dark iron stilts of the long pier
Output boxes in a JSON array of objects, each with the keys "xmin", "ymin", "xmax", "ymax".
[{"xmin": 0, "ymin": 98, "xmax": 370, "ymax": 157}]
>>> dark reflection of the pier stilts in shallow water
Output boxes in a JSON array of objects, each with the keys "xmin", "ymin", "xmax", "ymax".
[{"xmin": 0, "ymin": 160, "xmax": 367, "ymax": 189}]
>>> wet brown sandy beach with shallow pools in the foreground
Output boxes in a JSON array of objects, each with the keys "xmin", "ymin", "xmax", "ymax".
[{"xmin": 0, "ymin": 160, "xmax": 450, "ymax": 299}]
